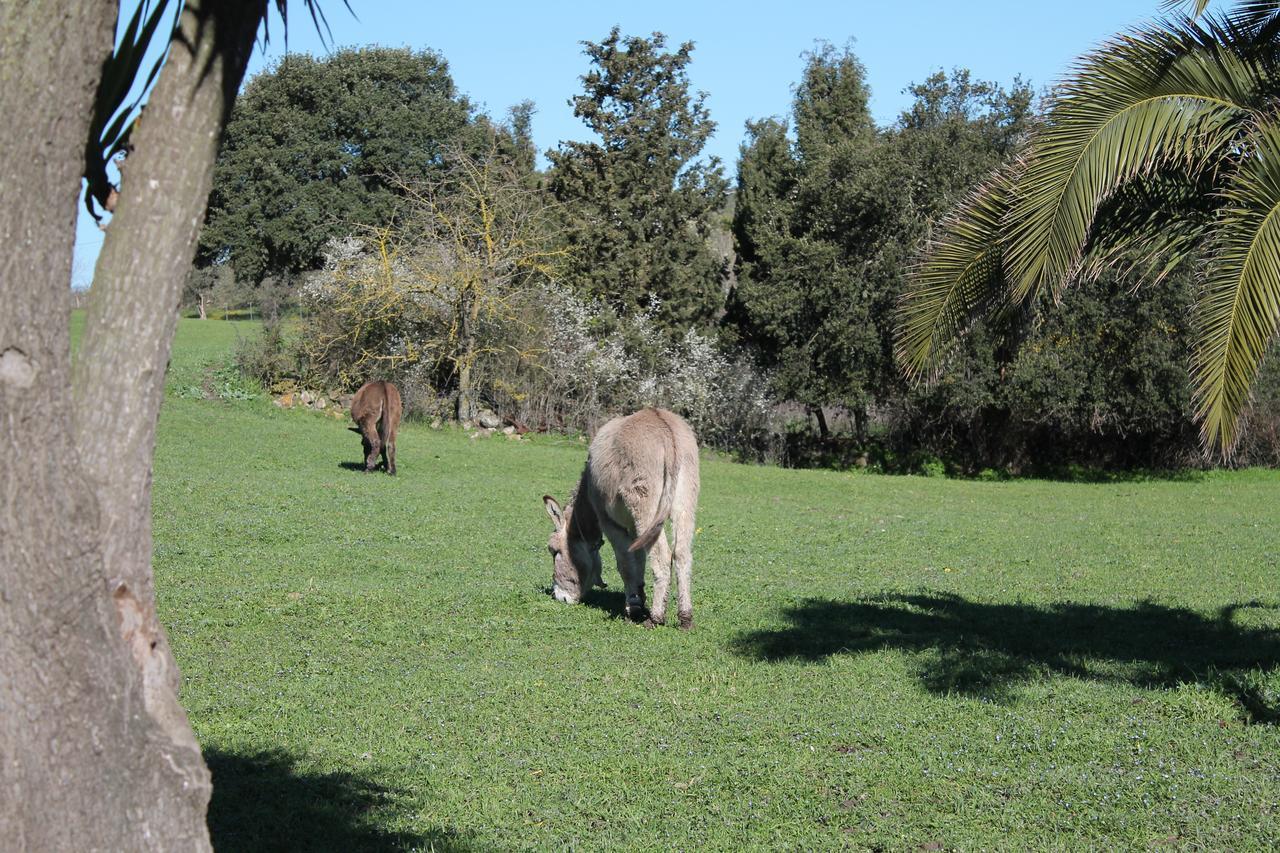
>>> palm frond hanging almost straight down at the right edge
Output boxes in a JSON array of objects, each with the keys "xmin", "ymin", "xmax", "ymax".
[{"xmin": 1192, "ymin": 123, "xmax": 1280, "ymax": 457}]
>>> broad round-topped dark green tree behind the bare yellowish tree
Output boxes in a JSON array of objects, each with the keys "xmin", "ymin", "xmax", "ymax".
[{"xmin": 197, "ymin": 47, "xmax": 532, "ymax": 282}]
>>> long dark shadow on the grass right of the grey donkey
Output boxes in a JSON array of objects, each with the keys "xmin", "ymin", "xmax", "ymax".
[{"xmin": 733, "ymin": 592, "xmax": 1280, "ymax": 724}]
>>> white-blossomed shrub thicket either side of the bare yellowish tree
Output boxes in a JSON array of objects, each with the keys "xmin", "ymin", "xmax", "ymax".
[{"xmin": 300, "ymin": 237, "xmax": 777, "ymax": 460}]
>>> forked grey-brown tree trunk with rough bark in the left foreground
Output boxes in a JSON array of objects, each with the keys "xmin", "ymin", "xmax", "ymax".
[{"xmin": 0, "ymin": 0, "xmax": 265, "ymax": 850}]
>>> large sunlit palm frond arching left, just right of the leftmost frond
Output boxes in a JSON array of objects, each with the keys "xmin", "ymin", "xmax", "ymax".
[{"xmin": 1005, "ymin": 19, "xmax": 1260, "ymax": 302}]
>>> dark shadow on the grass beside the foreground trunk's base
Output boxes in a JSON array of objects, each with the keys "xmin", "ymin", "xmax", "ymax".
[{"xmin": 205, "ymin": 749, "xmax": 477, "ymax": 853}]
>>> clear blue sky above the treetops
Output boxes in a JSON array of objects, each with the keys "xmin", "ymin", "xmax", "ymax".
[{"xmin": 72, "ymin": 0, "xmax": 1160, "ymax": 287}]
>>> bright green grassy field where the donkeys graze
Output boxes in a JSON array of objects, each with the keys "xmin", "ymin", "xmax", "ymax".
[{"xmin": 145, "ymin": 320, "xmax": 1280, "ymax": 850}]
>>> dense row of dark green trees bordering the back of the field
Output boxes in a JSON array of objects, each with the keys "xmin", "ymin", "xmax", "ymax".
[{"xmin": 207, "ymin": 28, "xmax": 1280, "ymax": 473}]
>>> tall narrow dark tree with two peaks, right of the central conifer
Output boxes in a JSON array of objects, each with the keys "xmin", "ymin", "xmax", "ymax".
[{"xmin": 727, "ymin": 45, "xmax": 878, "ymax": 434}]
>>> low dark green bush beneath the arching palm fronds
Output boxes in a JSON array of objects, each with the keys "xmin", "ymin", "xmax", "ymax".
[{"xmin": 888, "ymin": 269, "xmax": 1203, "ymax": 474}]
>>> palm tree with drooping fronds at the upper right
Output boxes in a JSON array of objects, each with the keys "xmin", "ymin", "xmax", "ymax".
[{"xmin": 897, "ymin": 0, "xmax": 1280, "ymax": 456}]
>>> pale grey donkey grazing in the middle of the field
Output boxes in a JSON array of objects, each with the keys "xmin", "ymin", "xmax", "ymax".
[{"xmin": 543, "ymin": 409, "xmax": 698, "ymax": 629}]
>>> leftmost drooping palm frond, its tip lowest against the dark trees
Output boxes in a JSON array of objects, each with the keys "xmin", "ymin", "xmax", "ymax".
[{"xmin": 895, "ymin": 165, "xmax": 1018, "ymax": 380}]
